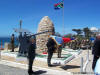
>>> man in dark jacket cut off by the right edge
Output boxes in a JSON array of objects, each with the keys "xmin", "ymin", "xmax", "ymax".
[{"xmin": 92, "ymin": 35, "xmax": 100, "ymax": 70}]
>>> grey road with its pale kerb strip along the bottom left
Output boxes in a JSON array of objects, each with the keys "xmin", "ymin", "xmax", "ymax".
[{"xmin": 0, "ymin": 60, "xmax": 71, "ymax": 75}]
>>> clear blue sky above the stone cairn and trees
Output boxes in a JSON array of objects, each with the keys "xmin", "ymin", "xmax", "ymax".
[{"xmin": 0, "ymin": 0, "xmax": 100, "ymax": 36}]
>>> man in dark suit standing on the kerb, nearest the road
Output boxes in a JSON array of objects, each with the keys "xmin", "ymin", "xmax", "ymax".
[{"xmin": 28, "ymin": 38, "xmax": 36, "ymax": 75}]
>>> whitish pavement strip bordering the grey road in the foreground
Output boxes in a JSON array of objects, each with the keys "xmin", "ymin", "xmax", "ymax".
[{"xmin": 0, "ymin": 60, "xmax": 71, "ymax": 75}]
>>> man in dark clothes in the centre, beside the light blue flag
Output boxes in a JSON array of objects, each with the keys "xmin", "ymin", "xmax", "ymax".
[{"xmin": 47, "ymin": 37, "xmax": 56, "ymax": 67}]
